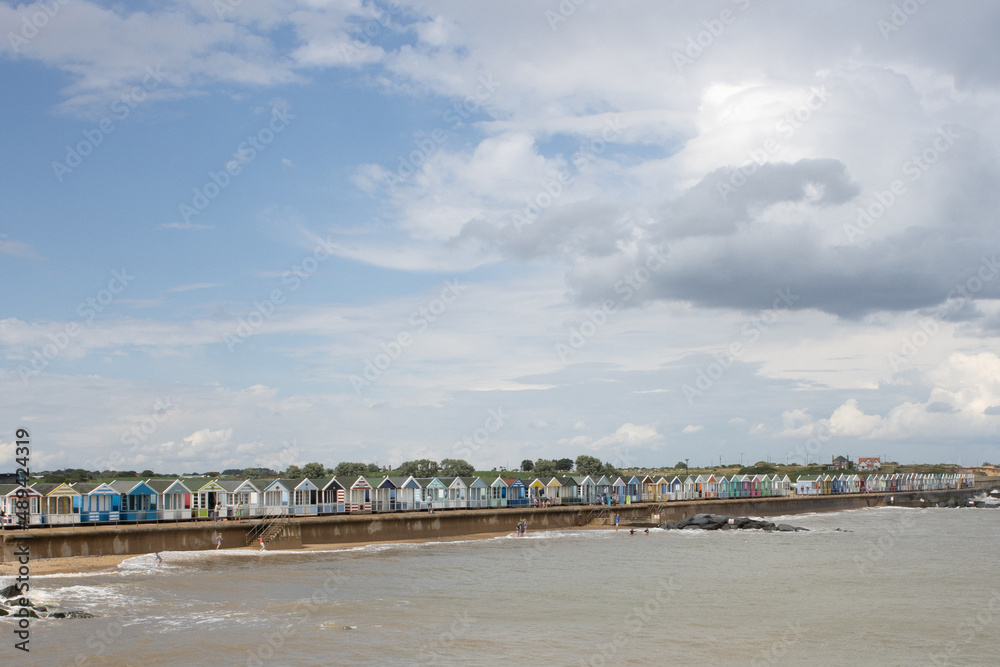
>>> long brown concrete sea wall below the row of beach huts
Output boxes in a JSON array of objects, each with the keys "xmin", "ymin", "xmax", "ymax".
[{"xmin": 0, "ymin": 489, "xmax": 977, "ymax": 562}]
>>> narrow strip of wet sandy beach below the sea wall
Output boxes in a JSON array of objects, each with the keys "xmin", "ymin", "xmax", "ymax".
[{"xmin": 0, "ymin": 526, "xmax": 609, "ymax": 580}]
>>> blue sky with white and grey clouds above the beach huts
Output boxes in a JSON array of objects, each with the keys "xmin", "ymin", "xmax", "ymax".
[{"xmin": 0, "ymin": 0, "xmax": 1000, "ymax": 473}]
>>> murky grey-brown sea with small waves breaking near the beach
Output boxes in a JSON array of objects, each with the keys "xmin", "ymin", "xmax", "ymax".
[{"xmin": 7, "ymin": 508, "xmax": 1000, "ymax": 667}]
